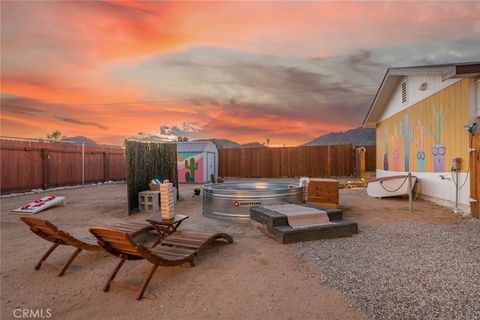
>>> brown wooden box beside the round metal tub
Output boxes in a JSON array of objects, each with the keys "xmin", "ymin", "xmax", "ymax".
[{"xmin": 307, "ymin": 179, "xmax": 339, "ymax": 208}]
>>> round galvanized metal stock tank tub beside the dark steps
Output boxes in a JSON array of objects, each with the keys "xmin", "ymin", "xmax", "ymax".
[{"xmin": 203, "ymin": 182, "xmax": 303, "ymax": 220}]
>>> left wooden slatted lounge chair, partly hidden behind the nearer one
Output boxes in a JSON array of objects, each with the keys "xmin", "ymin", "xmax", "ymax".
[{"xmin": 20, "ymin": 217, "xmax": 152, "ymax": 277}]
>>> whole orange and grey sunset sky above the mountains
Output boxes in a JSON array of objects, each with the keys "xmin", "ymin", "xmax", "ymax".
[{"xmin": 1, "ymin": 1, "xmax": 480, "ymax": 144}]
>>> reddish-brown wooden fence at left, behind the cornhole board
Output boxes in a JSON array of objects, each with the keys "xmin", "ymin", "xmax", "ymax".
[{"xmin": 0, "ymin": 139, "xmax": 126, "ymax": 194}]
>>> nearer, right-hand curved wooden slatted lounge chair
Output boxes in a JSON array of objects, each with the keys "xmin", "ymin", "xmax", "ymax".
[{"xmin": 90, "ymin": 228, "xmax": 233, "ymax": 300}]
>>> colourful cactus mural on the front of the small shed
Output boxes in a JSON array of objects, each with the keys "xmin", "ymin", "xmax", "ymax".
[{"xmin": 177, "ymin": 152, "xmax": 205, "ymax": 183}]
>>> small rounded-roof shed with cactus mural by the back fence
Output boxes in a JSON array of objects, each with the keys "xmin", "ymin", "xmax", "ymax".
[{"xmin": 177, "ymin": 141, "xmax": 218, "ymax": 183}]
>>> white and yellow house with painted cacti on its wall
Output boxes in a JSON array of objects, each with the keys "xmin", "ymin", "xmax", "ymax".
[{"xmin": 363, "ymin": 62, "xmax": 480, "ymax": 217}]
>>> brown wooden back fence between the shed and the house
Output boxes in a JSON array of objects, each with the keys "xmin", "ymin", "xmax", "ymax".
[{"xmin": 219, "ymin": 144, "xmax": 355, "ymax": 178}]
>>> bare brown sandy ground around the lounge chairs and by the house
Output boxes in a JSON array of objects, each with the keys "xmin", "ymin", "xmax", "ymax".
[{"xmin": 1, "ymin": 180, "xmax": 462, "ymax": 319}]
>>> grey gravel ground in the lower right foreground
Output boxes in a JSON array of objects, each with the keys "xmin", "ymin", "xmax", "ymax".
[{"xmin": 295, "ymin": 219, "xmax": 480, "ymax": 320}]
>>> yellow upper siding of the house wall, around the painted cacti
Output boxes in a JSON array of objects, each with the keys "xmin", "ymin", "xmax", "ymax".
[{"xmin": 376, "ymin": 79, "xmax": 470, "ymax": 172}]
